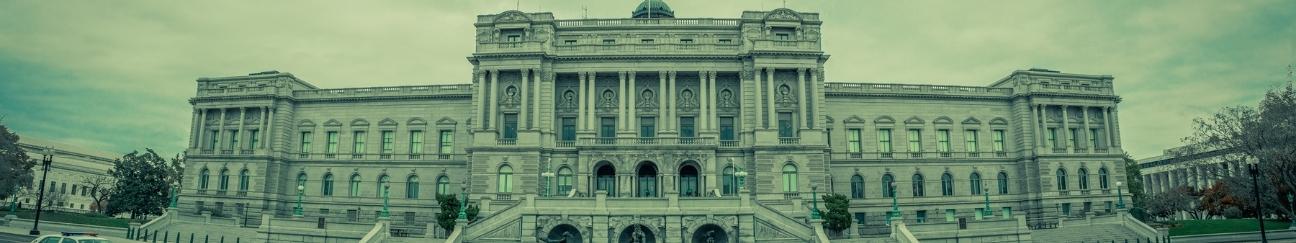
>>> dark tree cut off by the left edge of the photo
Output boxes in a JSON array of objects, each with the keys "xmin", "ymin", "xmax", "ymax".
[{"xmin": 0, "ymin": 124, "xmax": 36, "ymax": 199}]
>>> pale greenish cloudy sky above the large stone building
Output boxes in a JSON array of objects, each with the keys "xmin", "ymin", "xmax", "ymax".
[{"xmin": 0, "ymin": 0, "xmax": 1296, "ymax": 158}]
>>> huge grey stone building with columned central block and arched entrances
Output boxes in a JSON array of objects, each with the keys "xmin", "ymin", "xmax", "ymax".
[{"xmin": 179, "ymin": 0, "xmax": 1145, "ymax": 242}]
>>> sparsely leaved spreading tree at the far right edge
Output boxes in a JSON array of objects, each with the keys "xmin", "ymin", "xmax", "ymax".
[{"xmin": 1185, "ymin": 84, "xmax": 1296, "ymax": 217}]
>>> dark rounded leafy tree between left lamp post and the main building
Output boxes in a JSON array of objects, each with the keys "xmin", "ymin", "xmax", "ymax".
[{"xmin": 105, "ymin": 149, "xmax": 176, "ymax": 218}]
